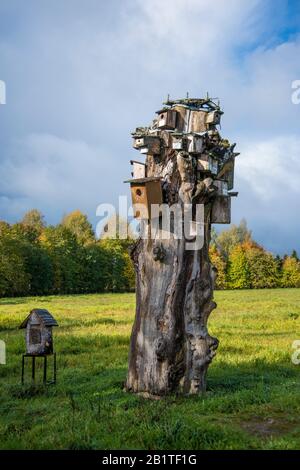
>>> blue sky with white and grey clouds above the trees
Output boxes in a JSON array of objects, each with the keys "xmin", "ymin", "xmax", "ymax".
[{"xmin": 0, "ymin": 0, "xmax": 300, "ymax": 254}]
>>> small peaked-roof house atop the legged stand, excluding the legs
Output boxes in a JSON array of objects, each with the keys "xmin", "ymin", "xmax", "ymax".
[{"xmin": 20, "ymin": 308, "xmax": 58, "ymax": 355}]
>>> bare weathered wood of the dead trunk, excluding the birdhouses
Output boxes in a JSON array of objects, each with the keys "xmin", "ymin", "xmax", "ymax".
[{"xmin": 126, "ymin": 99, "xmax": 238, "ymax": 395}]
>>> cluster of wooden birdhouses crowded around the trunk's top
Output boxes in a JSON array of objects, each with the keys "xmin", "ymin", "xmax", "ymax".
[{"xmin": 126, "ymin": 97, "xmax": 238, "ymax": 224}]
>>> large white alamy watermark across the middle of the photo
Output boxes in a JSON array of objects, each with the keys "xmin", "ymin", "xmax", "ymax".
[{"xmin": 96, "ymin": 196, "xmax": 205, "ymax": 250}]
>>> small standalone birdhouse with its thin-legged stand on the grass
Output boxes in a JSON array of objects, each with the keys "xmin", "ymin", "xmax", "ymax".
[{"xmin": 19, "ymin": 308, "xmax": 58, "ymax": 384}]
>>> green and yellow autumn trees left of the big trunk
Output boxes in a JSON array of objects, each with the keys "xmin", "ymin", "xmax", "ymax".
[{"xmin": 0, "ymin": 209, "xmax": 135, "ymax": 297}]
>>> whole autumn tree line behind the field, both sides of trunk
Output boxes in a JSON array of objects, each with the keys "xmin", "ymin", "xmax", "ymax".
[{"xmin": 0, "ymin": 209, "xmax": 300, "ymax": 297}]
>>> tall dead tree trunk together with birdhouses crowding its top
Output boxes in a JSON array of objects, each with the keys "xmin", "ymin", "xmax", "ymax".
[{"xmin": 126, "ymin": 96, "xmax": 236, "ymax": 395}]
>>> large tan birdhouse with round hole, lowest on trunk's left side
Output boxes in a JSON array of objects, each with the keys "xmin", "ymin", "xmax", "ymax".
[{"xmin": 125, "ymin": 177, "xmax": 163, "ymax": 219}]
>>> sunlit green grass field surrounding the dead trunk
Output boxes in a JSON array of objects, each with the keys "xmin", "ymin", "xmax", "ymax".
[{"xmin": 0, "ymin": 289, "xmax": 300, "ymax": 450}]
